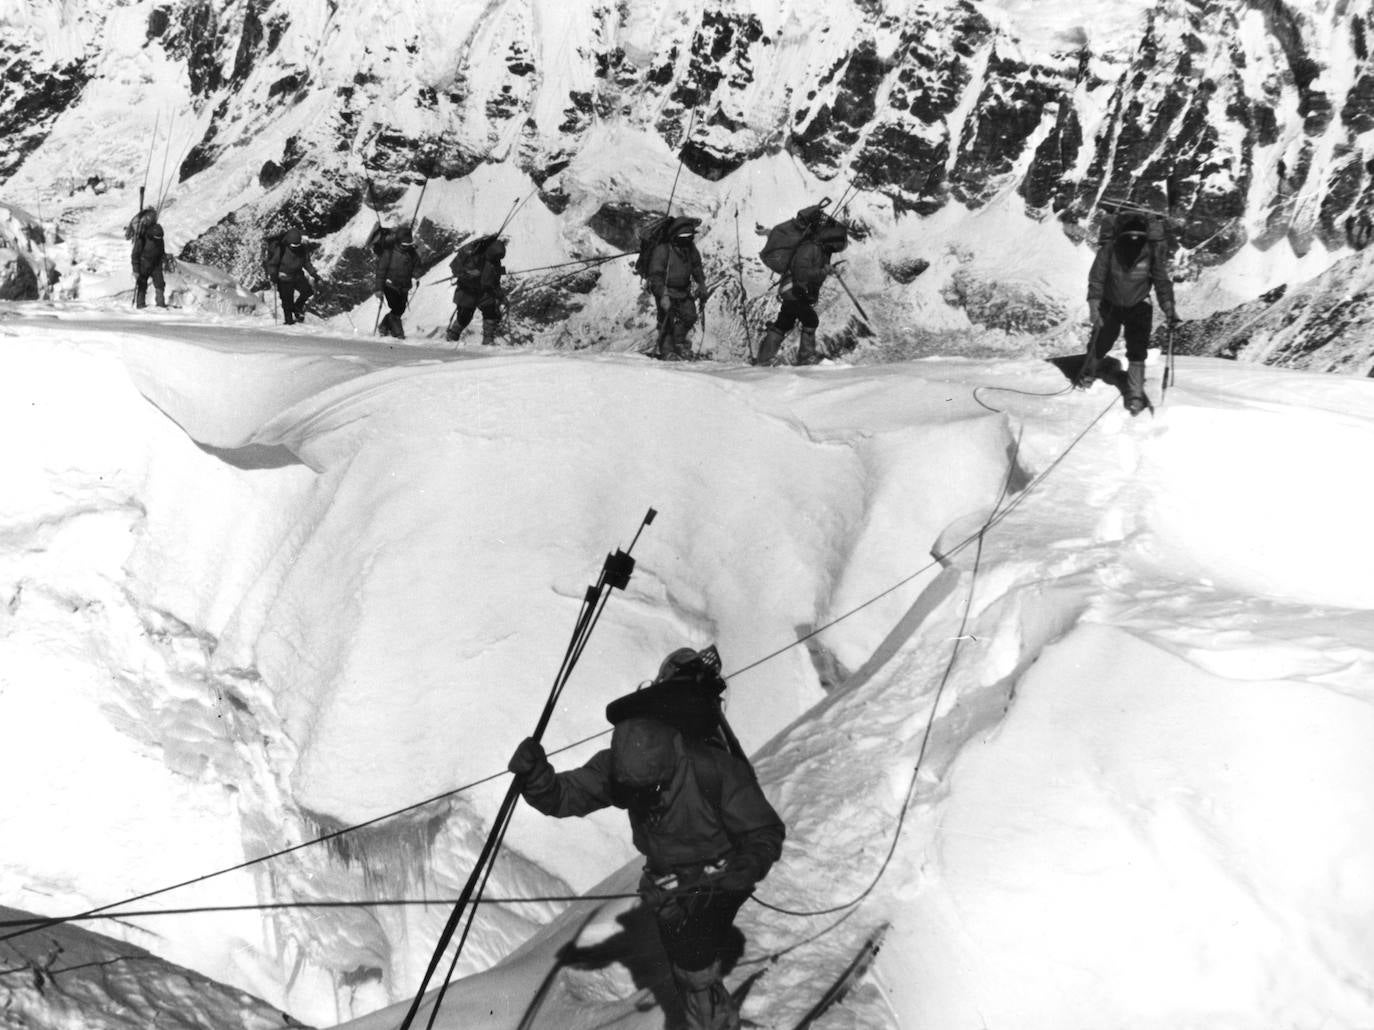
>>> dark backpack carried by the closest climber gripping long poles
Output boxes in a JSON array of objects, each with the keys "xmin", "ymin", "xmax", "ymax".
[{"xmin": 606, "ymin": 645, "xmax": 754, "ymax": 808}]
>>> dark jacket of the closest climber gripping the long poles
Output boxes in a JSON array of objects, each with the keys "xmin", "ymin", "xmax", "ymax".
[{"xmin": 523, "ymin": 744, "xmax": 786, "ymax": 879}]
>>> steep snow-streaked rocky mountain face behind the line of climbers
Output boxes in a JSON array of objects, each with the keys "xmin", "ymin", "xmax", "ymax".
[{"xmin": 8, "ymin": 0, "xmax": 1374, "ymax": 354}]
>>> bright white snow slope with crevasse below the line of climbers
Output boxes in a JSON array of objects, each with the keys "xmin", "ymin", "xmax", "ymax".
[{"xmin": 0, "ymin": 305, "xmax": 1374, "ymax": 1030}]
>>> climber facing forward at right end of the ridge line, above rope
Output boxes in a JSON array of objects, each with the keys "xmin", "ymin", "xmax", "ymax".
[{"xmin": 1079, "ymin": 211, "xmax": 1178, "ymax": 415}]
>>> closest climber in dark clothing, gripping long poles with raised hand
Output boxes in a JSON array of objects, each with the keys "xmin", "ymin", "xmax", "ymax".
[{"xmin": 510, "ymin": 647, "xmax": 785, "ymax": 1030}]
